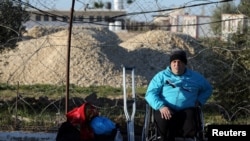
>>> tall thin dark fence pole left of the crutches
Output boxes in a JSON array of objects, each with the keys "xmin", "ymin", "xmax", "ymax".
[{"xmin": 65, "ymin": 0, "xmax": 75, "ymax": 114}]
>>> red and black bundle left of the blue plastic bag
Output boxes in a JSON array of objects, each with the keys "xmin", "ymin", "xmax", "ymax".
[{"xmin": 66, "ymin": 103, "xmax": 98, "ymax": 141}]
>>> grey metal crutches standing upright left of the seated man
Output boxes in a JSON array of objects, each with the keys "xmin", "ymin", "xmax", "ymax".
[{"xmin": 123, "ymin": 66, "xmax": 136, "ymax": 141}]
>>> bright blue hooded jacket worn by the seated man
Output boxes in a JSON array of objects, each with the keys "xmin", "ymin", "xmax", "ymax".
[{"xmin": 145, "ymin": 66, "xmax": 212, "ymax": 111}]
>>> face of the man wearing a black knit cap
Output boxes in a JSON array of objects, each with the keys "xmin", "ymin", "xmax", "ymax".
[{"xmin": 170, "ymin": 59, "xmax": 186, "ymax": 75}]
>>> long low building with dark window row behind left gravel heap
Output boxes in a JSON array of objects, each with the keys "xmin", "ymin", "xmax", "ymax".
[{"xmin": 24, "ymin": 0, "xmax": 126, "ymax": 32}]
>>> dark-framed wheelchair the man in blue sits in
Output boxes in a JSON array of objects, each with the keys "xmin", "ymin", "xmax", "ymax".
[{"xmin": 142, "ymin": 104, "xmax": 206, "ymax": 141}]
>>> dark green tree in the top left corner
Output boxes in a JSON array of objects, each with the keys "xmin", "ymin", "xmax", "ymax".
[{"xmin": 0, "ymin": 0, "xmax": 28, "ymax": 49}]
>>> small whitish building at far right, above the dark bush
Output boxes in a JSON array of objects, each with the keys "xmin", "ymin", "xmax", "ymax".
[{"xmin": 221, "ymin": 14, "xmax": 248, "ymax": 41}]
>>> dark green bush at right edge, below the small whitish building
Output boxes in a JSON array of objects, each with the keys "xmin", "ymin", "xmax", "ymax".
[{"xmin": 213, "ymin": 46, "xmax": 250, "ymax": 122}]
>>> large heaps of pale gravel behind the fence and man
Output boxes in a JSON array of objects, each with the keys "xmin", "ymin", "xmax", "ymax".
[{"xmin": 0, "ymin": 28, "xmax": 211, "ymax": 87}]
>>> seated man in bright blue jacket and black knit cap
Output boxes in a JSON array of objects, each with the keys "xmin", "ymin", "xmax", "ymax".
[{"xmin": 145, "ymin": 50, "xmax": 212, "ymax": 141}]
